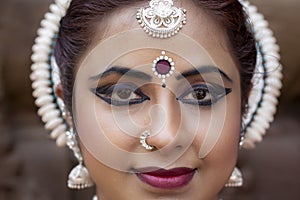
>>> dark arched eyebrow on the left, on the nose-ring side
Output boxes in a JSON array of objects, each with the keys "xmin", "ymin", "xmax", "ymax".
[{"xmin": 89, "ymin": 66, "xmax": 152, "ymax": 81}]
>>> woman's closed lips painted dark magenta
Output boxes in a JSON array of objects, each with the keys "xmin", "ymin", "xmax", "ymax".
[{"xmin": 136, "ymin": 167, "xmax": 196, "ymax": 189}]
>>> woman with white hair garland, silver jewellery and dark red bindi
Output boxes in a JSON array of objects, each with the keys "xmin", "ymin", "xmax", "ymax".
[{"xmin": 31, "ymin": 0, "xmax": 281, "ymax": 200}]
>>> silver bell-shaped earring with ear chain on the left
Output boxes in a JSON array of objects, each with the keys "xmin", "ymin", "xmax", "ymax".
[{"xmin": 66, "ymin": 129, "xmax": 94, "ymax": 189}]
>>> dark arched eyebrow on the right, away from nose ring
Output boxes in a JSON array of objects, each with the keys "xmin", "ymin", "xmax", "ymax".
[{"xmin": 176, "ymin": 66, "xmax": 232, "ymax": 83}]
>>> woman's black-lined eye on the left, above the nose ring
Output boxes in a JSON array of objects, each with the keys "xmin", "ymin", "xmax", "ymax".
[{"xmin": 91, "ymin": 84, "xmax": 150, "ymax": 106}]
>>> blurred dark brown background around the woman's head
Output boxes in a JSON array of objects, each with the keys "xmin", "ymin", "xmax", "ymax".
[{"xmin": 0, "ymin": 0, "xmax": 300, "ymax": 200}]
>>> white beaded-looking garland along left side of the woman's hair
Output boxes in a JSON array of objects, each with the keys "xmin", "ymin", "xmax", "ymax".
[{"xmin": 30, "ymin": 0, "xmax": 70, "ymax": 146}]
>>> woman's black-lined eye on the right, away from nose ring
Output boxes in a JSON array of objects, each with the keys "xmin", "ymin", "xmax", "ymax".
[{"xmin": 177, "ymin": 84, "xmax": 232, "ymax": 106}]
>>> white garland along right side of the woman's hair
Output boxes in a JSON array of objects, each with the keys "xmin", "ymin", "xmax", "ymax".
[{"xmin": 240, "ymin": 0, "xmax": 282, "ymax": 148}]
